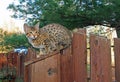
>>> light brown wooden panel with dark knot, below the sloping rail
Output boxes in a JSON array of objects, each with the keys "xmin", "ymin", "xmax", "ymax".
[{"xmin": 31, "ymin": 54, "xmax": 60, "ymax": 82}]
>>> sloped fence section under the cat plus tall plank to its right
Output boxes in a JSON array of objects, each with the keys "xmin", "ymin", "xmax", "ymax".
[{"xmin": 24, "ymin": 30, "xmax": 87, "ymax": 82}]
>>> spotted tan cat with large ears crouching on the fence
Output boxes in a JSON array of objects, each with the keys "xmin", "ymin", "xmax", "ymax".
[{"xmin": 24, "ymin": 23, "xmax": 71, "ymax": 55}]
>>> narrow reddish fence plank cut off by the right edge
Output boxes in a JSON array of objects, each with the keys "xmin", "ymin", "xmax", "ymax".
[{"xmin": 114, "ymin": 38, "xmax": 120, "ymax": 82}]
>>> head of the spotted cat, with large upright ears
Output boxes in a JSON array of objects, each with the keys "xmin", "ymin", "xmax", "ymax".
[{"xmin": 24, "ymin": 23, "xmax": 39, "ymax": 39}]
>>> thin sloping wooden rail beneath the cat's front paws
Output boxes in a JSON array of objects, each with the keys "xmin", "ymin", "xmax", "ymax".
[{"xmin": 24, "ymin": 51, "xmax": 60, "ymax": 66}]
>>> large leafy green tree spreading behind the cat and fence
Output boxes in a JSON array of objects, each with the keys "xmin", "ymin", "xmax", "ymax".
[{"xmin": 8, "ymin": 0, "xmax": 120, "ymax": 36}]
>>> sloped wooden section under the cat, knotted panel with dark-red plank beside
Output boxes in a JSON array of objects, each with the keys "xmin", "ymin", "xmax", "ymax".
[{"xmin": 24, "ymin": 48, "xmax": 73, "ymax": 82}]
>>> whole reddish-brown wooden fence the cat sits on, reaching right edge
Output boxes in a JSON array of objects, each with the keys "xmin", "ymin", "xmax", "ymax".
[{"xmin": 0, "ymin": 30, "xmax": 120, "ymax": 82}]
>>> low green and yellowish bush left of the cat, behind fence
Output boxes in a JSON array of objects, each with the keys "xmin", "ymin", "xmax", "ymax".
[{"xmin": 0, "ymin": 32, "xmax": 30, "ymax": 52}]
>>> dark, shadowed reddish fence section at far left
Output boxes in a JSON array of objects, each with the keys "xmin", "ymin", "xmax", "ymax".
[{"xmin": 0, "ymin": 52, "xmax": 19, "ymax": 82}]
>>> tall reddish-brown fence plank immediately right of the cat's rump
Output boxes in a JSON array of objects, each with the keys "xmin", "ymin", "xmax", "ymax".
[{"xmin": 72, "ymin": 30, "xmax": 87, "ymax": 82}]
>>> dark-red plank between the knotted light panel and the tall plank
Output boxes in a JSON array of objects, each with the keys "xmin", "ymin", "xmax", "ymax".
[{"xmin": 60, "ymin": 47, "xmax": 73, "ymax": 82}]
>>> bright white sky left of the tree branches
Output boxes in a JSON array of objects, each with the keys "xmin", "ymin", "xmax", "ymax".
[{"xmin": 0, "ymin": 0, "xmax": 23, "ymax": 31}]
